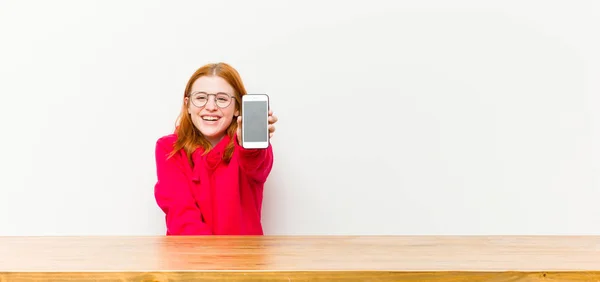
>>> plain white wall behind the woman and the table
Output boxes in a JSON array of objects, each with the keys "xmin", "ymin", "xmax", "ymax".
[{"xmin": 0, "ymin": 0, "xmax": 600, "ymax": 235}]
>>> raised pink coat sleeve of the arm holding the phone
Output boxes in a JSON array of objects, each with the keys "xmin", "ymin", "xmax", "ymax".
[{"xmin": 234, "ymin": 138, "xmax": 273, "ymax": 184}]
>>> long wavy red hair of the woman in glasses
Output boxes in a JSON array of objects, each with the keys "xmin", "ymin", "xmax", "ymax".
[{"xmin": 171, "ymin": 63, "xmax": 246, "ymax": 164}]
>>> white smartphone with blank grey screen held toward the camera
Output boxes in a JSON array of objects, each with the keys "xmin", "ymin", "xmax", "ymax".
[{"xmin": 242, "ymin": 94, "xmax": 269, "ymax": 149}]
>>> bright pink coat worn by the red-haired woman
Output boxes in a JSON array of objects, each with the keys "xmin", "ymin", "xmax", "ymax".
[{"xmin": 154, "ymin": 134, "xmax": 273, "ymax": 235}]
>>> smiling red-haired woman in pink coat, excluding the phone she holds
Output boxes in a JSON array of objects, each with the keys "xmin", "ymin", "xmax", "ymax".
[{"xmin": 154, "ymin": 63, "xmax": 277, "ymax": 235}]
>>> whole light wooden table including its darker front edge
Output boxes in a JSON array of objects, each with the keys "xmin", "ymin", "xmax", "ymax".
[{"xmin": 0, "ymin": 236, "xmax": 600, "ymax": 281}]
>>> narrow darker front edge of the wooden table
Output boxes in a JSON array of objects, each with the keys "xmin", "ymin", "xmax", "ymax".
[{"xmin": 0, "ymin": 271, "xmax": 600, "ymax": 282}]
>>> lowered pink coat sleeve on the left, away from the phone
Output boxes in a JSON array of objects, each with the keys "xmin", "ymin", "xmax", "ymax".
[{"xmin": 154, "ymin": 140, "xmax": 211, "ymax": 235}]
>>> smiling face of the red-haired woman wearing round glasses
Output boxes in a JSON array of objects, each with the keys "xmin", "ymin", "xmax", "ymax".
[{"xmin": 185, "ymin": 76, "xmax": 239, "ymax": 146}]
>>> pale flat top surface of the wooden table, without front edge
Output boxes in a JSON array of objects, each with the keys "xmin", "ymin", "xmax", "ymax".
[{"xmin": 0, "ymin": 236, "xmax": 600, "ymax": 272}]
